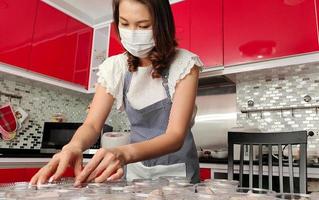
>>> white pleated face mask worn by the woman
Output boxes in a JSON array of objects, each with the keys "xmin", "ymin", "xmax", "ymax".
[{"xmin": 119, "ymin": 28, "xmax": 155, "ymax": 58}]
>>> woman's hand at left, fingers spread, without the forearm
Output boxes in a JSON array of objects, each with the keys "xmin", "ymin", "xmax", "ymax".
[{"xmin": 30, "ymin": 144, "xmax": 83, "ymax": 185}]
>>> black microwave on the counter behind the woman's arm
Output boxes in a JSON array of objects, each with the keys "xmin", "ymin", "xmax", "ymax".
[{"xmin": 40, "ymin": 122, "xmax": 113, "ymax": 157}]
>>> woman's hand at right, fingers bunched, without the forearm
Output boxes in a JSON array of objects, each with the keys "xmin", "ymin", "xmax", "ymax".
[{"xmin": 74, "ymin": 148, "xmax": 124, "ymax": 186}]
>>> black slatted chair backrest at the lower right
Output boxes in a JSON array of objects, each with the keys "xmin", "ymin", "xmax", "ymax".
[{"xmin": 228, "ymin": 131, "xmax": 307, "ymax": 193}]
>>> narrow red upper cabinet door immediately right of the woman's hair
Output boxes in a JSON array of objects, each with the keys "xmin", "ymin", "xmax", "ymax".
[{"xmin": 171, "ymin": 0, "xmax": 190, "ymax": 49}]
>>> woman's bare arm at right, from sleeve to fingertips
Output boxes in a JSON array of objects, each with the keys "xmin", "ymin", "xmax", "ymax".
[{"xmin": 75, "ymin": 66, "xmax": 199, "ymax": 185}]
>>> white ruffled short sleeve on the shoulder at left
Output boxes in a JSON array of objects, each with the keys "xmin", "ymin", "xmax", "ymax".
[{"xmin": 97, "ymin": 54, "xmax": 127, "ymax": 109}]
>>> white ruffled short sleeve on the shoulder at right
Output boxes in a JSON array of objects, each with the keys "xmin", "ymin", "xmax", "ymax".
[{"xmin": 168, "ymin": 49, "xmax": 203, "ymax": 99}]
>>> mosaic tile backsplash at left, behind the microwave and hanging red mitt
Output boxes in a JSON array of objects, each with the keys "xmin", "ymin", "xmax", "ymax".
[{"xmin": 0, "ymin": 74, "xmax": 129, "ymax": 149}]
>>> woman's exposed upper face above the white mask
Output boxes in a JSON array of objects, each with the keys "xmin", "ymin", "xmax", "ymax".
[{"xmin": 119, "ymin": 0, "xmax": 152, "ymax": 30}]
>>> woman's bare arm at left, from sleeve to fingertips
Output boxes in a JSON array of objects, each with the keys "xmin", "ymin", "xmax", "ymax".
[{"xmin": 30, "ymin": 86, "xmax": 114, "ymax": 185}]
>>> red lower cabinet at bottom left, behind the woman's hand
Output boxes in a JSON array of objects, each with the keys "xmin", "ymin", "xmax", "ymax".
[{"xmin": 0, "ymin": 168, "xmax": 74, "ymax": 183}]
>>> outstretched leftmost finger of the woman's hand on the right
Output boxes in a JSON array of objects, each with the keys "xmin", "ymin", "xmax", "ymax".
[{"xmin": 74, "ymin": 149, "xmax": 105, "ymax": 186}]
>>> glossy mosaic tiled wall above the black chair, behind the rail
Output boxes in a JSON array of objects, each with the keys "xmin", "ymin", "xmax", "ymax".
[{"xmin": 236, "ymin": 63, "xmax": 319, "ymax": 155}]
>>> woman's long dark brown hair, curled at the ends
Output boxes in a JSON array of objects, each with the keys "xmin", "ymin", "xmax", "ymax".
[{"xmin": 113, "ymin": 0, "xmax": 177, "ymax": 78}]
